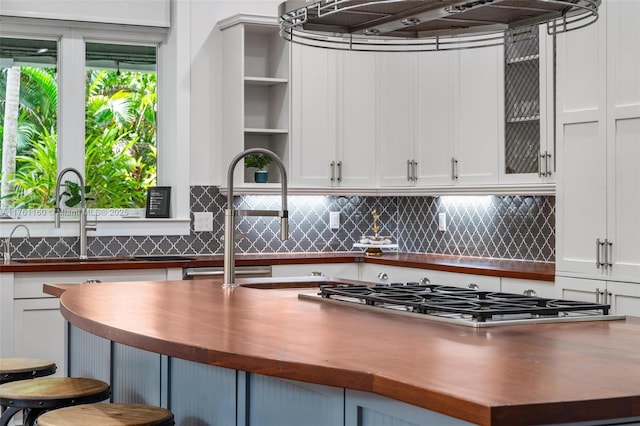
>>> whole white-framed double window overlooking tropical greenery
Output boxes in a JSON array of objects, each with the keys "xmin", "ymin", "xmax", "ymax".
[{"xmin": 0, "ymin": 21, "xmax": 165, "ymax": 226}]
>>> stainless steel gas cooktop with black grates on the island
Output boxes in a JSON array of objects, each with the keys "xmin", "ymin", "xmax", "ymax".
[{"xmin": 299, "ymin": 283, "xmax": 624, "ymax": 327}]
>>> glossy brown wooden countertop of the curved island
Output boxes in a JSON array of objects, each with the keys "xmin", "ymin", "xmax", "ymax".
[{"xmin": 45, "ymin": 277, "xmax": 640, "ymax": 426}]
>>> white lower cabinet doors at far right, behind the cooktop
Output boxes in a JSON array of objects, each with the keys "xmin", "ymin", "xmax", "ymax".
[{"xmin": 556, "ymin": 276, "xmax": 640, "ymax": 316}]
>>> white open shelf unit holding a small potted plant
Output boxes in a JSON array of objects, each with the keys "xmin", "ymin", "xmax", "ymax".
[{"xmin": 218, "ymin": 14, "xmax": 290, "ymax": 188}]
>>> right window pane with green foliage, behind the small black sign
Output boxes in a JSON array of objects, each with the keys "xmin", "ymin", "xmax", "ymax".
[{"xmin": 85, "ymin": 42, "xmax": 157, "ymax": 208}]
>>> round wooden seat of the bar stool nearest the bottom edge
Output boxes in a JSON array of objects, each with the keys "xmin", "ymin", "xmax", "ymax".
[{"xmin": 38, "ymin": 403, "xmax": 174, "ymax": 426}]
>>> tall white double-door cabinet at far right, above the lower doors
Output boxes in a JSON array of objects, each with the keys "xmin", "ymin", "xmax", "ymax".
[{"xmin": 556, "ymin": 1, "xmax": 640, "ymax": 282}]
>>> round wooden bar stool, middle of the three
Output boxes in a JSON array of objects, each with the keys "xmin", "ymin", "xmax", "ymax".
[{"xmin": 0, "ymin": 377, "xmax": 111, "ymax": 426}]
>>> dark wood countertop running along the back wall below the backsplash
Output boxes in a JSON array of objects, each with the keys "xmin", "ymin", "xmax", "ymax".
[{"xmin": 0, "ymin": 252, "xmax": 555, "ymax": 282}]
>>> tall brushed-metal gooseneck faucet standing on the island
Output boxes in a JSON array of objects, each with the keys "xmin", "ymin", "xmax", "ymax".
[{"xmin": 222, "ymin": 148, "xmax": 289, "ymax": 287}]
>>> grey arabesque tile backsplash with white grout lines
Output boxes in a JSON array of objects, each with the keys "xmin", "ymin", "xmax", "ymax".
[{"xmin": 7, "ymin": 186, "xmax": 555, "ymax": 261}]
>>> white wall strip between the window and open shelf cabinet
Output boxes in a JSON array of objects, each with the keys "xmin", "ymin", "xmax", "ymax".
[{"xmin": 185, "ymin": 0, "xmax": 284, "ymax": 185}]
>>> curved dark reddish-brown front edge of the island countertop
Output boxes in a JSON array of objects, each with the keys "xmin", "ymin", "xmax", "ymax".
[{"xmin": 43, "ymin": 277, "xmax": 640, "ymax": 426}]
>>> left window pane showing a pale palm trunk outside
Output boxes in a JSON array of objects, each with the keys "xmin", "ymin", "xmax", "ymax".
[{"xmin": 0, "ymin": 37, "xmax": 58, "ymax": 210}]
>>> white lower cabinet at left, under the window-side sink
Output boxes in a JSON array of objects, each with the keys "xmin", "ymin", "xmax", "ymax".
[{"xmin": 0, "ymin": 269, "xmax": 167, "ymax": 376}]
